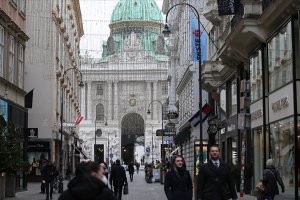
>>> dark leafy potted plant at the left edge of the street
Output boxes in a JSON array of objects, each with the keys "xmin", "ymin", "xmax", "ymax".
[{"xmin": 0, "ymin": 123, "xmax": 28, "ymax": 197}]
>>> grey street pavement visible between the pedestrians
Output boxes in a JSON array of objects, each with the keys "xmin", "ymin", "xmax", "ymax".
[{"xmin": 6, "ymin": 171, "xmax": 291, "ymax": 200}]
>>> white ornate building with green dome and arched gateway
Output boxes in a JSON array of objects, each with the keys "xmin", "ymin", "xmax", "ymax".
[{"xmin": 80, "ymin": 0, "xmax": 168, "ymax": 163}]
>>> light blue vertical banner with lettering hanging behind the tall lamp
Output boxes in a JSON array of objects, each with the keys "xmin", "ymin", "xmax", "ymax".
[{"xmin": 189, "ymin": 12, "xmax": 207, "ymax": 62}]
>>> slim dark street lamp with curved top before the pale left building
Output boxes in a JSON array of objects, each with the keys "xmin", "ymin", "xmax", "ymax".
[{"xmin": 58, "ymin": 67, "xmax": 84, "ymax": 193}]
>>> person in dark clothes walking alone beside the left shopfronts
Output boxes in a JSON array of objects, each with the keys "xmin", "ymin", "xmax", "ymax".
[{"xmin": 41, "ymin": 160, "xmax": 59, "ymax": 200}]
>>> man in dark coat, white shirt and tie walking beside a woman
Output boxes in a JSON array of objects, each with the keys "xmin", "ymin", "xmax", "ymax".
[{"xmin": 198, "ymin": 145, "xmax": 237, "ymax": 200}]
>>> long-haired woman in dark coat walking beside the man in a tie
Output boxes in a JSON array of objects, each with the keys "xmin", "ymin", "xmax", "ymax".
[{"xmin": 164, "ymin": 155, "xmax": 193, "ymax": 200}]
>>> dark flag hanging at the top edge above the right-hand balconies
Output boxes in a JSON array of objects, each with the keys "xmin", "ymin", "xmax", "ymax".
[{"xmin": 218, "ymin": 0, "xmax": 240, "ymax": 16}]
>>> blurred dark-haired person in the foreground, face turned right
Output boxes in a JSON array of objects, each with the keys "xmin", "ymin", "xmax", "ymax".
[{"xmin": 58, "ymin": 161, "xmax": 116, "ymax": 200}]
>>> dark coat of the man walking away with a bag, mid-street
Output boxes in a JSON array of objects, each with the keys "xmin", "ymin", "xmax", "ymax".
[{"xmin": 109, "ymin": 164, "xmax": 127, "ymax": 187}]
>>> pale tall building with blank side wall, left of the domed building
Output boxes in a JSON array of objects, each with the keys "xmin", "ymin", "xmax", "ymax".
[{"xmin": 25, "ymin": 0, "xmax": 83, "ymax": 179}]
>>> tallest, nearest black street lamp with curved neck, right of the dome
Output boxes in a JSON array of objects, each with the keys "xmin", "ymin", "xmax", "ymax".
[{"xmin": 162, "ymin": 3, "xmax": 203, "ymax": 163}]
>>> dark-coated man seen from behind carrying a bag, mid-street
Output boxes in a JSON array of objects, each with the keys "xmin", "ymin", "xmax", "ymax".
[{"xmin": 109, "ymin": 159, "xmax": 128, "ymax": 200}]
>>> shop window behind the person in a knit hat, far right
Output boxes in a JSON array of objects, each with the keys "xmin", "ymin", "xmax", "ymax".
[{"xmin": 270, "ymin": 117, "xmax": 295, "ymax": 194}]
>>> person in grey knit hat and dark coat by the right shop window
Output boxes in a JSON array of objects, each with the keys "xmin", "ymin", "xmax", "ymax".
[{"xmin": 263, "ymin": 159, "xmax": 285, "ymax": 200}]
